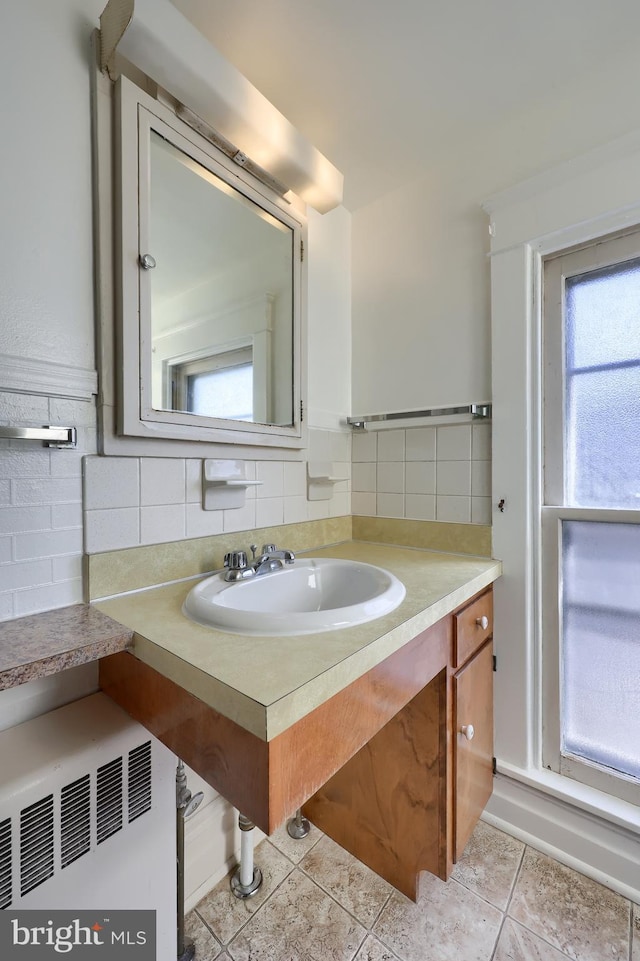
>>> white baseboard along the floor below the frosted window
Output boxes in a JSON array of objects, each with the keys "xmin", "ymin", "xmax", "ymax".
[{"xmin": 483, "ymin": 774, "xmax": 640, "ymax": 903}]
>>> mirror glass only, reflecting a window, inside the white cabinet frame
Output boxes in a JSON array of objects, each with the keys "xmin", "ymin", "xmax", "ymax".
[{"xmin": 149, "ymin": 131, "xmax": 294, "ymax": 426}]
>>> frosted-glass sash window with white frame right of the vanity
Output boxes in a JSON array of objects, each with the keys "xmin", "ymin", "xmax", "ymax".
[{"xmin": 542, "ymin": 233, "xmax": 640, "ymax": 800}]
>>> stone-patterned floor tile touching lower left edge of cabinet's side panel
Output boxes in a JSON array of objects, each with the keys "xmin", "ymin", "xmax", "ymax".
[{"xmin": 300, "ymin": 837, "xmax": 394, "ymax": 928}]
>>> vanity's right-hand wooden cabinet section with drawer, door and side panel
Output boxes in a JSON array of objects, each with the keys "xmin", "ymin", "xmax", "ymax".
[{"xmin": 304, "ymin": 589, "xmax": 493, "ymax": 900}]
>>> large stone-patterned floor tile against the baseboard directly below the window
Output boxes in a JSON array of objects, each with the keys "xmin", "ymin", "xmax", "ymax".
[{"xmin": 508, "ymin": 848, "xmax": 630, "ymax": 961}]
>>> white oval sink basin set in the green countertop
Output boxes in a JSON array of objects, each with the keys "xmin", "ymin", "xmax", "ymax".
[{"xmin": 182, "ymin": 557, "xmax": 405, "ymax": 635}]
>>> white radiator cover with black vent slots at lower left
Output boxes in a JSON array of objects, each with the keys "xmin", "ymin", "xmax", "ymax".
[{"xmin": 0, "ymin": 694, "xmax": 176, "ymax": 961}]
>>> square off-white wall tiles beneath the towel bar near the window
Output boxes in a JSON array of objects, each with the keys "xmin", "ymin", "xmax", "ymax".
[{"xmin": 351, "ymin": 424, "xmax": 491, "ymax": 524}]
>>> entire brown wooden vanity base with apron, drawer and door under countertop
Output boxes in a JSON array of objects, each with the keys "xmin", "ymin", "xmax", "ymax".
[{"xmin": 100, "ymin": 588, "xmax": 493, "ymax": 900}]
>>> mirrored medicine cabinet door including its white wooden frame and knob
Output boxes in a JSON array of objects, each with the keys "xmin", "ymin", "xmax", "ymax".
[{"xmin": 117, "ymin": 78, "xmax": 305, "ymax": 447}]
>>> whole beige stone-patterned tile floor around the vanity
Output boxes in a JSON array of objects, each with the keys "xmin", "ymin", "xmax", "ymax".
[{"xmin": 187, "ymin": 821, "xmax": 640, "ymax": 961}]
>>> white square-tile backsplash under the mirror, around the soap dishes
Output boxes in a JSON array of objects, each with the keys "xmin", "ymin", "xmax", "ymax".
[{"xmin": 84, "ymin": 430, "xmax": 351, "ymax": 554}]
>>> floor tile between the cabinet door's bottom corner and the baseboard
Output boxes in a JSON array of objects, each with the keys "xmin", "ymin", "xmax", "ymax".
[{"xmin": 452, "ymin": 821, "xmax": 525, "ymax": 911}]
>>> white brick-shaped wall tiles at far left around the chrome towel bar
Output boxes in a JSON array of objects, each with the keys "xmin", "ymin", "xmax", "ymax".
[{"xmin": 0, "ymin": 391, "xmax": 96, "ymax": 620}]
